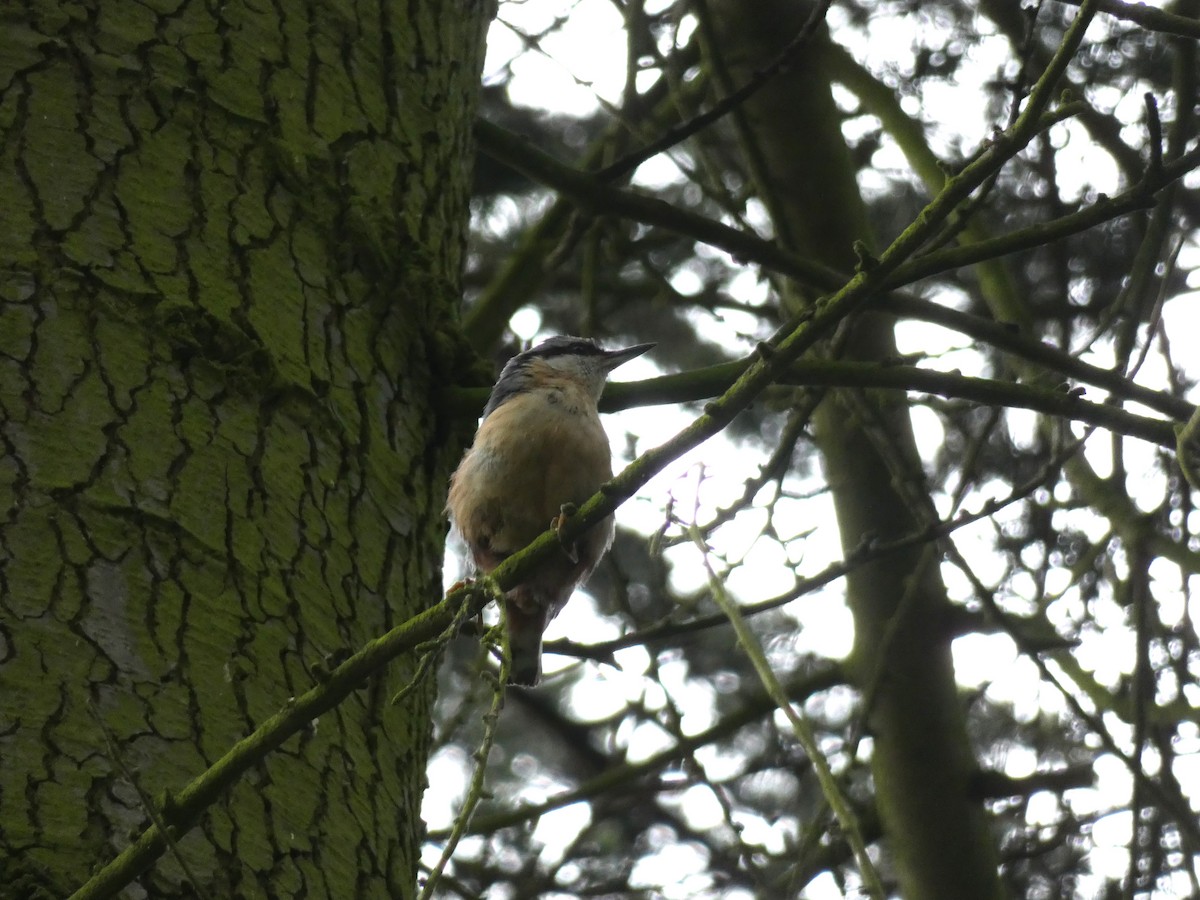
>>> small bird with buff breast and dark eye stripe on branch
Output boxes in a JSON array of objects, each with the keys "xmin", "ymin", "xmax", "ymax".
[{"xmin": 446, "ymin": 335, "xmax": 654, "ymax": 686}]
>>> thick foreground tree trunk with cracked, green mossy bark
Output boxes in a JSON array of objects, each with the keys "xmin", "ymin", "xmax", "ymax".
[{"xmin": 0, "ymin": 0, "xmax": 487, "ymax": 898}]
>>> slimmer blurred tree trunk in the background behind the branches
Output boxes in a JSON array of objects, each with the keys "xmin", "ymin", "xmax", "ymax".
[{"xmin": 709, "ymin": 0, "xmax": 1001, "ymax": 900}]
